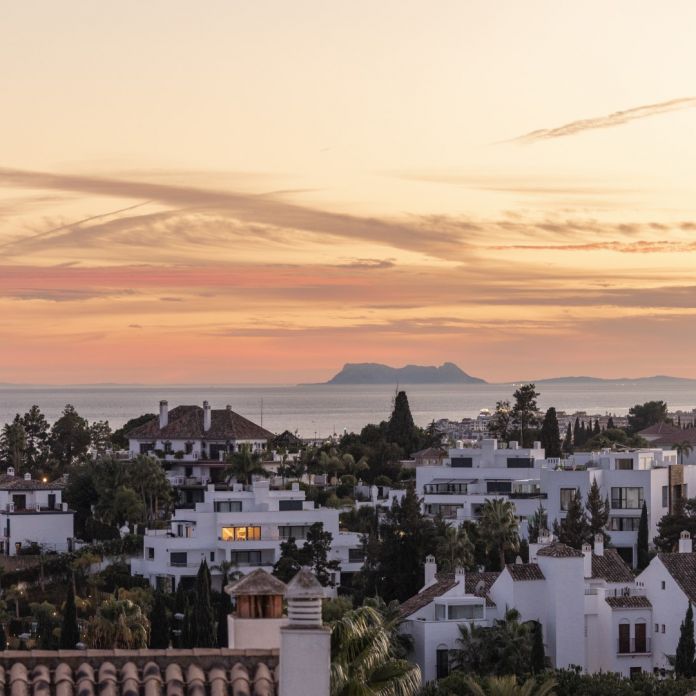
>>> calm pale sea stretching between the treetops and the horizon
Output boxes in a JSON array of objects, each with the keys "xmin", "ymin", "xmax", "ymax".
[{"xmin": 0, "ymin": 380, "xmax": 696, "ymax": 438}]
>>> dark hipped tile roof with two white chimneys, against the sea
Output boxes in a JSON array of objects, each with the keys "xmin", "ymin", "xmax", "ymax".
[{"xmin": 128, "ymin": 406, "xmax": 273, "ymax": 440}]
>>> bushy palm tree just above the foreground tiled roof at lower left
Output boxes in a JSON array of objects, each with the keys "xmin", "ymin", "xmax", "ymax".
[{"xmin": 86, "ymin": 597, "xmax": 150, "ymax": 650}]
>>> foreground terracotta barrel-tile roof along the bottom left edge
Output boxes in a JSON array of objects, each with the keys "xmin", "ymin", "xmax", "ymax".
[{"xmin": 0, "ymin": 649, "xmax": 278, "ymax": 696}]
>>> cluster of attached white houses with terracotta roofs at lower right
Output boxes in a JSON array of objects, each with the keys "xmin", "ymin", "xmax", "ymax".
[{"xmin": 401, "ymin": 535, "xmax": 676, "ymax": 681}]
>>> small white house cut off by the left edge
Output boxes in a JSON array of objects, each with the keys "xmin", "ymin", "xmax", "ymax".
[{"xmin": 0, "ymin": 467, "xmax": 75, "ymax": 556}]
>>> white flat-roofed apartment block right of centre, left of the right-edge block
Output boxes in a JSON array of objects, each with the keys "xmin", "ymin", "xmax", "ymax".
[{"xmin": 416, "ymin": 439, "xmax": 560, "ymax": 536}]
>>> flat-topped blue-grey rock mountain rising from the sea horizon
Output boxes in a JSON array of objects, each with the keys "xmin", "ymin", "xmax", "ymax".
[{"xmin": 324, "ymin": 363, "xmax": 486, "ymax": 384}]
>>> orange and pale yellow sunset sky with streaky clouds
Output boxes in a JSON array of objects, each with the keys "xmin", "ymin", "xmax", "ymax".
[{"xmin": 0, "ymin": 0, "xmax": 696, "ymax": 384}]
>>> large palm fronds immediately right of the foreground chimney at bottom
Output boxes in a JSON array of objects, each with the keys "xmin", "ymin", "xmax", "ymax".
[{"xmin": 331, "ymin": 607, "xmax": 421, "ymax": 696}]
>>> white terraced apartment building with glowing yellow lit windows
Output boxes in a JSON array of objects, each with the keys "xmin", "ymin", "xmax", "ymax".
[{"xmin": 131, "ymin": 480, "xmax": 363, "ymax": 588}]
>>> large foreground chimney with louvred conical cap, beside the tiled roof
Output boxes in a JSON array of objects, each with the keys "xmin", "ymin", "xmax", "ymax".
[{"xmin": 279, "ymin": 568, "xmax": 331, "ymax": 696}]
